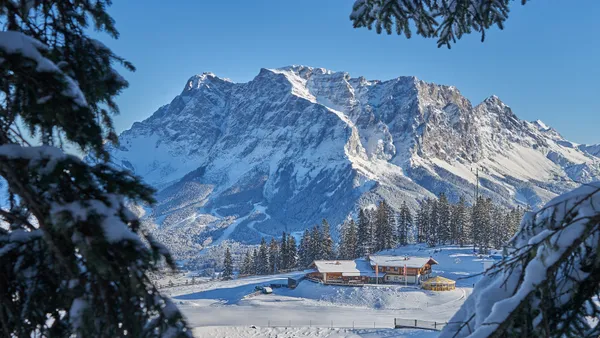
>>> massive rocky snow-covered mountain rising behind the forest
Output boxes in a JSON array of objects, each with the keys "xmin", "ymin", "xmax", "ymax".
[{"xmin": 111, "ymin": 66, "xmax": 600, "ymax": 247}]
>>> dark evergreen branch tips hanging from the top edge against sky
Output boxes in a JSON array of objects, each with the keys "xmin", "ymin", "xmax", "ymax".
[{"xmin": 350, "ymin": 0, "xmax": 527, "ymax": 48}]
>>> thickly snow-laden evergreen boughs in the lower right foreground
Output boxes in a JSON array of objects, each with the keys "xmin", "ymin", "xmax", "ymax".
[{"xmin": 440, "ymin": 182, "xmax": 600, "ymax": 338}]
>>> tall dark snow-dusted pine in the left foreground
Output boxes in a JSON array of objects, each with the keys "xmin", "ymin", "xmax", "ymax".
[{"xmin": 0, "ymin": 0, "xmax": 190, "ymax": 337}]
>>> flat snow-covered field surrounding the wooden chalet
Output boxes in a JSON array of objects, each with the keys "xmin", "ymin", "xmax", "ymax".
[{"xmin": 164, "ymin": 245, "xmax": 492, "ymax": 337}]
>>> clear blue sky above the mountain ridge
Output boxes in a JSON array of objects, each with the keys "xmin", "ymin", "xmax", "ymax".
[{"xmin": 100, "ymin": 0, "xmax": 600, "ymax": 143}]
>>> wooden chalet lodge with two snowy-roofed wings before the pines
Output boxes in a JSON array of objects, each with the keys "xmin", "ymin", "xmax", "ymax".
[{"xmin": 306, "ymin": 255, "xmax": 438, "ymax": 285}]
